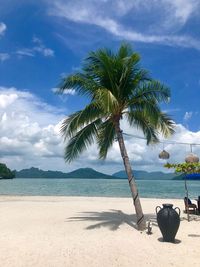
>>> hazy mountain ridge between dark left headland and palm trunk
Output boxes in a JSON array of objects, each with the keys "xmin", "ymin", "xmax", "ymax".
[{"xmin": 15, "ymin": 167, "xmax": 117, "ymax": 179}]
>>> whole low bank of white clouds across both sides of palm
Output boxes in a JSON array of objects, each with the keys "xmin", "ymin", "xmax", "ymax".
[{"xmin": 0, "ymin": 87, "xmax": 200, "ymax": 173}]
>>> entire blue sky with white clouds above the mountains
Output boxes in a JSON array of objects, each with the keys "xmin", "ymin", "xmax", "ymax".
[{"xmin": 0, "ymin": 0, "xmax": 200, "ymax": 174}]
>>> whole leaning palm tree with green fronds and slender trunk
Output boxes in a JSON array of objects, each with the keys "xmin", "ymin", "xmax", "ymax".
[{"xmin": 59, "ymin": 44, "xmax": 173, "ymax": 230}]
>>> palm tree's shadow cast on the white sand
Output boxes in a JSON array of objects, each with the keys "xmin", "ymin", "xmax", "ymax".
[{"xmin": 67, "ymin": 209, "xmax": 157, "ymax": 231}]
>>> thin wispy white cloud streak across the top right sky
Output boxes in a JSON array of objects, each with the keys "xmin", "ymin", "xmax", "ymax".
[{"xmin": 47, "ymin": 0, "xmax": 200, "ymax": 50}]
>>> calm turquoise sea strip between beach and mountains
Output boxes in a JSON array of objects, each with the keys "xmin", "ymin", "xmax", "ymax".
[{"xmin": 0, "ymin": 178, "xmax": 200, "ymax": 199}]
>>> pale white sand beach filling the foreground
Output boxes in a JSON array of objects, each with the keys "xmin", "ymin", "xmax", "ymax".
[{"xmin": 0, "ymin": 196, "xmax": 200, "ymax": 267}]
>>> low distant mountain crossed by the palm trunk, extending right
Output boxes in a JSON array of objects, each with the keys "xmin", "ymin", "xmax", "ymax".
[{"xmin": 113, "ymin": 170, "xmax": 180, "ymax": 180}]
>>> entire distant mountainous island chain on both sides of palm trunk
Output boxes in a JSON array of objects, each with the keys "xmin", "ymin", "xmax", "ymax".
[{"xmin": 12, "ymin": 167, "xmax": 184, "ymax": 180}]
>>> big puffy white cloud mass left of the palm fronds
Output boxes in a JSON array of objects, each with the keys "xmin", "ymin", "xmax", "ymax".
[{"xmin": 0, "ymin": 87, "xmax": 64, "ymax": 172}]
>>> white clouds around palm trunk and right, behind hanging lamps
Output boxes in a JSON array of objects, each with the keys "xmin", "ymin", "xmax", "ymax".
[{"xmin": 99, "ymin": 122, "xmax": 200, "ymax": 171}]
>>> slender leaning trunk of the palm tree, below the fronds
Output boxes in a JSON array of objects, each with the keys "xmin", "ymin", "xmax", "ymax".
[{"xmin": 115, "ymin": 123, "xmax": 146, "ymax": 231}]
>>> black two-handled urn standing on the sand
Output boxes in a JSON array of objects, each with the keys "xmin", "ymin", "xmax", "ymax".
[{"xmin": 156, "ymin": 204, "xmax": 180, "ymax": 242}]
